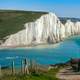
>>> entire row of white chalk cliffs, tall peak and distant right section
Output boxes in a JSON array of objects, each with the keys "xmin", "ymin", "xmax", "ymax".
[{"xmin": 1, "ymin": 13, "xmax": 80, "ymax": 46}]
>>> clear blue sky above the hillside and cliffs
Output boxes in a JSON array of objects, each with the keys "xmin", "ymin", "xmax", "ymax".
[{"xmin": 0, "ymin": 0, "xmax": 80, "ymax": 18}]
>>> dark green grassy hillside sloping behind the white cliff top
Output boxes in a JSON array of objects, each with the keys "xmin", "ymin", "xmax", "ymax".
[{"xmin": 0, "ymin": 10, "xmax": 46, "ymax": 39}]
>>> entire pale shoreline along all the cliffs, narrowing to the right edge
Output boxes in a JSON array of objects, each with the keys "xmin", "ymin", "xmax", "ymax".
[{"xmin": 0, "ymin": 35, "xmax": 80, "ymax": 50}]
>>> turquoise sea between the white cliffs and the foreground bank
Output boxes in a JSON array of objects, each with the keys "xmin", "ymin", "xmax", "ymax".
[{"xmin": 0, "ymin": 36, "xmax": 80, "ymax": 66}]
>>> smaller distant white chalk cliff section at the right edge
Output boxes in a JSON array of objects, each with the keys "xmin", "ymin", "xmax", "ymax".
[{"xmin": 65, "ymin": 20, "xmax": 80, "ymax": 37}]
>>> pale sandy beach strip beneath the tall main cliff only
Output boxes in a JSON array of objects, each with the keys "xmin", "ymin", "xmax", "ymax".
[{"xmin": 0, "ymin": 42, "xmax": 62, "ymax": 50}]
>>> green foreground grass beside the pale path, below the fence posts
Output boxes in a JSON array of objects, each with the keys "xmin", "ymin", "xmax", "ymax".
[{"xmin": 0, "ymin": 68, "xmax": 59, "ymax": 80}]
